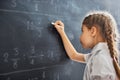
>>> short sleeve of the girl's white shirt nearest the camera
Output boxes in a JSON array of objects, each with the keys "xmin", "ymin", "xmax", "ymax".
[{"xmin": 90, "ymin": 53, "xmax": 116, "ymax": 80}]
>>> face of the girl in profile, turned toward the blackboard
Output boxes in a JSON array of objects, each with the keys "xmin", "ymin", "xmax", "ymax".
[{"xmin": 80, "ymin": 25, "xmax": 94, "ymax": 49}]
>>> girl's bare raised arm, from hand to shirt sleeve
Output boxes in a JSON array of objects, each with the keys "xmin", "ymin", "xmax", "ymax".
[{"xmin": 54, "ymin": 21, "xmax": 85, "ymax": 62}]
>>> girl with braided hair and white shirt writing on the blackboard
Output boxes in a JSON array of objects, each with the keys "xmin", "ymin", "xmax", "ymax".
[{"xmin": 54, "ymin": 11, "xmax": 120, "ymax": 80}]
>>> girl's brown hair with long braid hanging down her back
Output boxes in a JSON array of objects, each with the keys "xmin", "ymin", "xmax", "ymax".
[{"xmin": 82, "ymin": 11, "xmax": 120, "ymax": 78}]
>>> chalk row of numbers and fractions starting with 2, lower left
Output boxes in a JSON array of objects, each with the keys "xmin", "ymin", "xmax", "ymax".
[{"xmin": 1, "ymin": 45, "xmax": 61, "ymax": 69}]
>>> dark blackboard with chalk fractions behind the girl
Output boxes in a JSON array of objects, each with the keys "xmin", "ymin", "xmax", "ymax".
[{"xmin": 0, "ymin": 0, "xmax": 120, "ymax": 80}]
